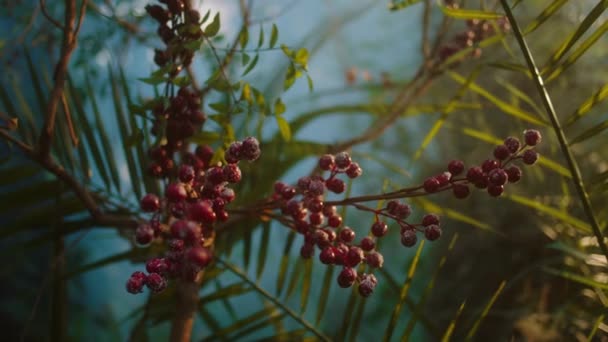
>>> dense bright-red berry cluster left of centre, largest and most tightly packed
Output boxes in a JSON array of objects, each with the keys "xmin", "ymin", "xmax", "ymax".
[{"xmin": 127, "ymin": 137, "xmax": 261, "ymax": 293}]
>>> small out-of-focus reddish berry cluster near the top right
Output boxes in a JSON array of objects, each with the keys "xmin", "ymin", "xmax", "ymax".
[{"xmin": 439, "ymin": 15, "xmax": 511, "ymax": 62}]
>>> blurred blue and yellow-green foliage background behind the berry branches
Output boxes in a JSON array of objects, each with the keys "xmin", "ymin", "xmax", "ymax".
[{"xmin": 0, "ymin": 0, "xmax": 608, "ymax": 341}]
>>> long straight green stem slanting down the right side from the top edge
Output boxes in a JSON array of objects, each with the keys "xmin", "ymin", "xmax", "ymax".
[{"xmin": 500, "ymin": 0, "xmax": 608, "ymax": 261}]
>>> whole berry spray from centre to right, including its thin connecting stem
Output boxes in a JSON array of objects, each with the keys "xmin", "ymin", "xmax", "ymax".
[{"xmin": 272, "ymin": 130, "xmax": 541, "ymax": 297}]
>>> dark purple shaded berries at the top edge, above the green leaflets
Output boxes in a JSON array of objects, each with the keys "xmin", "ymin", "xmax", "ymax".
[{"xmin": 146, "ymin": 0, "xmax": 203, "ymax": 77}]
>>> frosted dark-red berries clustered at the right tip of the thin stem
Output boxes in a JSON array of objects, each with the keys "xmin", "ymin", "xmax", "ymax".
[{"xmin": 423, "ymin": 129, "xmax": 542, "ymax": 199}]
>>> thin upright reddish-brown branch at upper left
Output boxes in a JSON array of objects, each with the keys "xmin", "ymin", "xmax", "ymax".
[{"xmin": 38, "ymin": 0, "xmax": 83, "ymax": 158}]
